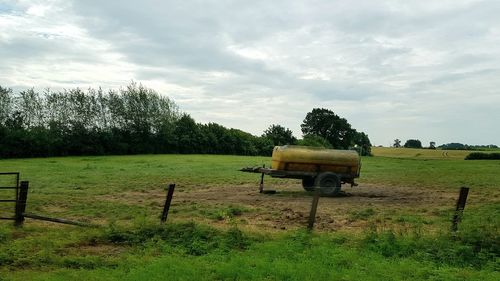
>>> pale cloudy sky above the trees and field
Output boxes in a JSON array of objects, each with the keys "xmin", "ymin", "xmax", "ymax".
[{"xmin": 0, "ymin": 0, "xmax": 500, "ymax": 146}]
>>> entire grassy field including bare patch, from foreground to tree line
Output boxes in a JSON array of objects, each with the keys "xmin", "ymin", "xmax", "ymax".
[{"xmin": 0, "ymin": 148, "xmax": 500, "ymax": 280}]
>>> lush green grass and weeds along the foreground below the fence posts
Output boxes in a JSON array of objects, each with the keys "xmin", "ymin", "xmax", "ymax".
[{"xmin": 2, "ymin": 224, "xmax": 498, "ymax": 280}]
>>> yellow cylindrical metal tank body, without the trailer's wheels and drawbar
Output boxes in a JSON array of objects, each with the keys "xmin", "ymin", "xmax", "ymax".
[{"xmin": 271, "ymin": 145, "xmax": 361, "ymax": 177}]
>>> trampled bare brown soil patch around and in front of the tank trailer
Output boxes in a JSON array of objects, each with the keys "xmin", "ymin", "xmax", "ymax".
[{"xmin": 183, "ymin": 184, "xmax": 456, "ymax": 230}]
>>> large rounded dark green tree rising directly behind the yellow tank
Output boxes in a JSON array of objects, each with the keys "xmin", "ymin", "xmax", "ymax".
[{"xmin": 300, "ymin": 108, "xmax": 356, "ymax": 149}]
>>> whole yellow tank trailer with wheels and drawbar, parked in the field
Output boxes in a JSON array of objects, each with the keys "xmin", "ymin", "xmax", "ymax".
[{"xmin": 241, "ymin": 145, "xmax": 361, "ymax": 195}]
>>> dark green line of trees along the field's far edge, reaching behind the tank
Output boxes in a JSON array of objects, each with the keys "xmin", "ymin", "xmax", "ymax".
[{"xmin": 0, "ymin": 83, "xmax": 371, "ymax": 158}]
